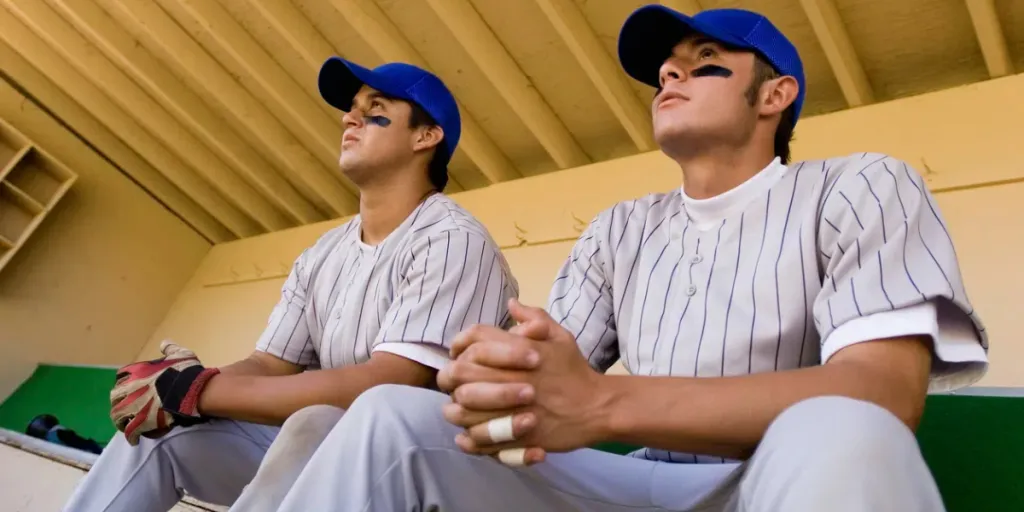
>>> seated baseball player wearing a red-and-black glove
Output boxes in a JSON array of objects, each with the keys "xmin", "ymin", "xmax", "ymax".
[{"xmin": 59, "ymin": 57, "xmax": 518, "ymax": 512}]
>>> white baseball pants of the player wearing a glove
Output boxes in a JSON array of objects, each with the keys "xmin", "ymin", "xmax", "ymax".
[{"xmin": 65, "ymin": 406, "xmax": 343, "ymax": 512}]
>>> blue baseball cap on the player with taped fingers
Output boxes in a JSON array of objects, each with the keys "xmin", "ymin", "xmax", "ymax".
[{"xmin": 618, "ymin": 5, "xmax": 807, "ymax": 121}]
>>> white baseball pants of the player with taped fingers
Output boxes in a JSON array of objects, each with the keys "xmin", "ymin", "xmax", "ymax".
[{"xmin": 268, "ymin": 385, "xmax": 944, "ymax": 512}]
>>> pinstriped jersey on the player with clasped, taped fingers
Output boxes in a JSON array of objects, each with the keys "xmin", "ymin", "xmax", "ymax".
[{"xmin": 548, "ymin": 154, "xmax": 987, "ymax": 462}]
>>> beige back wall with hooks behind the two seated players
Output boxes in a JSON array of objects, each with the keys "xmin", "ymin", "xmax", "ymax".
[{"xmin": 143, "ymin": 75, "xmax": 1024, "ymax": 385}]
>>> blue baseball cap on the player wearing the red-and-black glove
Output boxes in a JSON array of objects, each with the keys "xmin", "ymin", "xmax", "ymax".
[{"xmin": 316, "ymin": 57, "xmax": 462, "ymax": 164}]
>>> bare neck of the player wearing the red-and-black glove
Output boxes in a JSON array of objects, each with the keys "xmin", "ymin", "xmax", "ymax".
[{"xmin": 359, "ymin": 174, "xmax": 434, "ymax": 246}]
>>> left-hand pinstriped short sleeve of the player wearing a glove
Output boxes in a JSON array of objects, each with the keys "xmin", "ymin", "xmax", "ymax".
[{"xmin": 256, "ymin": 249, "xmax": 315, "ymax": 366}]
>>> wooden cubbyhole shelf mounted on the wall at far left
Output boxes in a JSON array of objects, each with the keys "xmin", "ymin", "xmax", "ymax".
[{"xmin": 0, "ymin": 120, "xmax": 78, "ymax": 271}]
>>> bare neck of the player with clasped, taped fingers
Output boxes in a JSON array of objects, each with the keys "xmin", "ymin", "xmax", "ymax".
[{"xmin": 675, "ymin": 140, "xmax": 775, "ymax": 199}]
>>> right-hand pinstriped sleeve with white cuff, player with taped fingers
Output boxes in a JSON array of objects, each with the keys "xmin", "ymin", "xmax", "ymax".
[{"xmin": 814, "ymin": 154, "xmax": 987, "ymax": 391}]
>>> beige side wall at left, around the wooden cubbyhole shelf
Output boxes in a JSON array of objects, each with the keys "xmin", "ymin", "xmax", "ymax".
[{"xmin": 0, "ymin": 75, "xmax": 210, "ymax": 385}]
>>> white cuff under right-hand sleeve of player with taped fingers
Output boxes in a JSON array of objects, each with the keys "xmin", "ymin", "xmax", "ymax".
[{"xmin": 821, "ymin": 300, "xmax": 988, "ymax": 392}]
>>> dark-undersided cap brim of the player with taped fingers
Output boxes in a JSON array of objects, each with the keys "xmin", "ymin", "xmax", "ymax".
[{"xmin": 618, "ymin": 5, "xmax": 746, "ymax": 87}]
